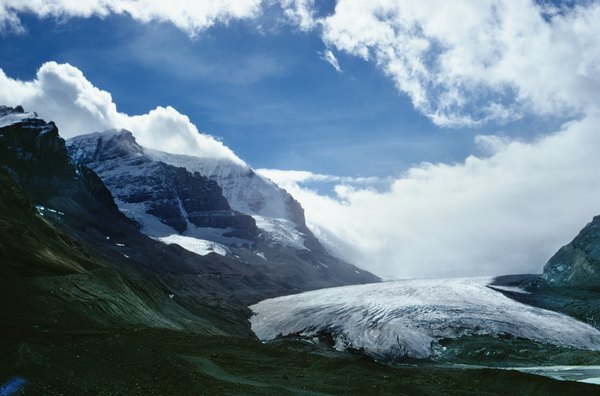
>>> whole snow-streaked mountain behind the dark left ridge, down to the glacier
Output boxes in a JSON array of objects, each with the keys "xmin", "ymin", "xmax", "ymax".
[{"xmin": 67, "ymin": 130, "xmax": 378, "ymax": 291}]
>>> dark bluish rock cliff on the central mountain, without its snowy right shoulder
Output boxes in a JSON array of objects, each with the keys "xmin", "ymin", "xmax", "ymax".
[{"xmin": 67, "ymin": 131, "xmax": 258, "ymax": 239}]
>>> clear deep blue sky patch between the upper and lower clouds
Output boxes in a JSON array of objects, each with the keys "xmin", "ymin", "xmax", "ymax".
[{"xmin": 0, "ymin": 9, "xmax": 557, "ymax": 177}]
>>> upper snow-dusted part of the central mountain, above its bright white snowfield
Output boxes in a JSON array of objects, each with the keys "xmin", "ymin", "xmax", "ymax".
[{"xmin": 67, "ymin": 130, "xmax": 315, "ymax": 249}]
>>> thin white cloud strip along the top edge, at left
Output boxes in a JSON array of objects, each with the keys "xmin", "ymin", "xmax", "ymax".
[{"xmin": 0, "ymin": 0, "xmax": 261, "ymax": 36}]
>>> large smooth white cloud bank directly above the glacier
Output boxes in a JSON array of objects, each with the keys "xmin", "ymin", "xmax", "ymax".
[{"xmin": 270, "ymin": 116, "xmax": 600, "ymax": 278}]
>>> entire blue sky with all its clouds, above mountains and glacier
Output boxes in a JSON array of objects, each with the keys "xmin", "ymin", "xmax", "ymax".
[{"xmin": 0, "ymin": 0, "xmax": 600, "ymax": 278}]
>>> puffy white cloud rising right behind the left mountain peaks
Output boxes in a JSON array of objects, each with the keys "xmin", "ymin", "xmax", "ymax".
[{"xmin": 0, "ymin": 62, "xmax": 243, "ymax": 163}]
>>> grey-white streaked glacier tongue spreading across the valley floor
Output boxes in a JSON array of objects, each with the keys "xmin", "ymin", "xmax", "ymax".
[{"xmin": 250, "ymin": 278, "xmax": 600, "ymax": 360}]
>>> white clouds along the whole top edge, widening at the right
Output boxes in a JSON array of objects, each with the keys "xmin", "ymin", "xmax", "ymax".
[{"xmin": 0, "ymin": 0, "xmax": 600, "ymax": 127}]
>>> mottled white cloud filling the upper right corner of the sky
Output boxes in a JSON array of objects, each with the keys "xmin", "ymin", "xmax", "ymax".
[{"xmin": 284, "ymin": 0, "xmax": 600, "ymax": 126}]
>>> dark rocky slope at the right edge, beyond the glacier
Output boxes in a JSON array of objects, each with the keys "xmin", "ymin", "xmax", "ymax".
[{"xmin": 543, "ymin": 216, "xmax": 600, "ymax": 287}]
